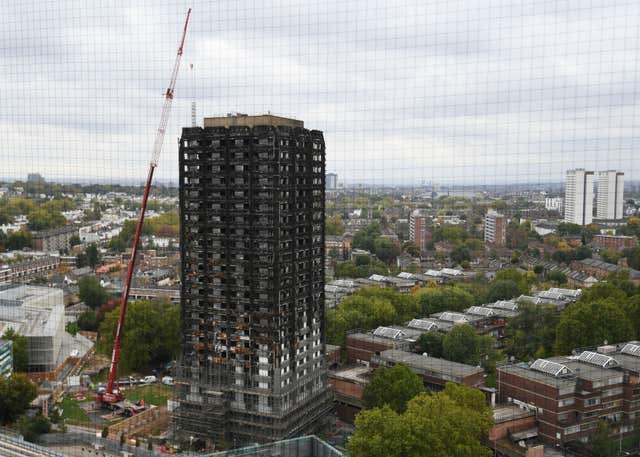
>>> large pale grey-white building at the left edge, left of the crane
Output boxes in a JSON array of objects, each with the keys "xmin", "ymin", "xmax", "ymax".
[{"xmin": 0, "ymin": 284, "xmax": 66, "ymax": 372}]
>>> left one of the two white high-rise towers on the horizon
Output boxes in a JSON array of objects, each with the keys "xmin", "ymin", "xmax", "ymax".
[{"xmin": 564, "ymin": 168, "xmax": 593, "ymax": 225}]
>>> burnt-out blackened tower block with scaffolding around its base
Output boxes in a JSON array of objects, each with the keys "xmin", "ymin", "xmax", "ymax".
[{"xmin": 173, "ymin": 116, "xmax": 331, "ymax": 444}]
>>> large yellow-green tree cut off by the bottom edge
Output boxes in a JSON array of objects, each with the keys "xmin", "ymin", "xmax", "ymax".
[{"xmin": 348, "ymin": 383, "xmax": 493, "ymax": 457}]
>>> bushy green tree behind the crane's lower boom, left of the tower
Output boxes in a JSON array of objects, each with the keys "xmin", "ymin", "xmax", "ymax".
[{"xmin": 96, "ymin": 300, "xmax": 180, "ymax": 372}]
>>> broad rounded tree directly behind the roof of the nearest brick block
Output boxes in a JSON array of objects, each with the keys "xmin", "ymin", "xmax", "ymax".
[{"xmin": 554, "ymin": 299, "xmax": 635, "ymax": 354}]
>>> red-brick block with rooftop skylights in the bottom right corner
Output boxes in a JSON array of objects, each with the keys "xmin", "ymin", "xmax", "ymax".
[{"xmin": 497, "ymin": 342, "xmax": 640, "ymax": 446}]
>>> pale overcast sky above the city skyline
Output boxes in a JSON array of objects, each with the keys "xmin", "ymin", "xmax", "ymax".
[{"xmin": 0, "ymin": 0, "xmax": 640, "ymax": 185}]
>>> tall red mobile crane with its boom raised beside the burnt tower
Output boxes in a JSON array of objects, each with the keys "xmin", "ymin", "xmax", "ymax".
[{"xmin": 98, "ymin": 8, "xmax": 191, "ymax": 408}]
